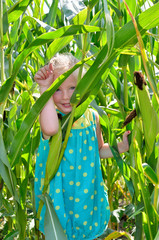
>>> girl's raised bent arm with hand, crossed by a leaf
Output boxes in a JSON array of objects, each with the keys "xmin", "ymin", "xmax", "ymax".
[{"xmin": 34, "ymin": 64, "xmax": 59, "ymax": 139}]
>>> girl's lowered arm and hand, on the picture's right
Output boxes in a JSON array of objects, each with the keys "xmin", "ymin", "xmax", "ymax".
[{"xmin": 96, "ymin": 114, "xmax": 130, "ymax": 158}]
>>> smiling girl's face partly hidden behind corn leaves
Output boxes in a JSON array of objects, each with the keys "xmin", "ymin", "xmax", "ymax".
[{"xmin": 53, "ymin": 73, "xmax": 77, "ymax": 114}]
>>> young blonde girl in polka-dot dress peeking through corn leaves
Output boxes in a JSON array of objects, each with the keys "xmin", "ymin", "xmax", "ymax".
[{"xmin": 34, "ymin": 54, "xmax": 130, "ymax": 240}]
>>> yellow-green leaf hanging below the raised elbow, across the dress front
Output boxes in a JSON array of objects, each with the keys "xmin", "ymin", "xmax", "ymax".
[{"xmin": 43, "ymin": 121, "xmax": 62, "ymax": 192}]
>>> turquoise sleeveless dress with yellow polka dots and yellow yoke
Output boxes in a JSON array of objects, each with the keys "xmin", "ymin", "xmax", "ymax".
[{"xmin": 34, "ymin": 108, "xmax": 110, "ymax": 240}]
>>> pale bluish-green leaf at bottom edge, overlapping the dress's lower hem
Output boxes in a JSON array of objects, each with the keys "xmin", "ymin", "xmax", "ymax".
[{"xmin": 42, "ymin": 194, "xmax": 67, "ymax": 240}]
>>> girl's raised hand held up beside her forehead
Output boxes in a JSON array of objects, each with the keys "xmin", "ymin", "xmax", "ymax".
[{"xmin": 34, "ymin": 63, "xmax": 54, "ymax": 89}]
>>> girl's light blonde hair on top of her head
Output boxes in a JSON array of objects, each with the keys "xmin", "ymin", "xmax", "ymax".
[{"xmin": 50, "ymin": 53, "xmax": 85, "ymax": 78}]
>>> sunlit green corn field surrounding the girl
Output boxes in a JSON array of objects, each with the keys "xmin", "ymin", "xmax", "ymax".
[{"xmin": 0, "ymin": 0, "xmax": 159, "ymax": 240}]
